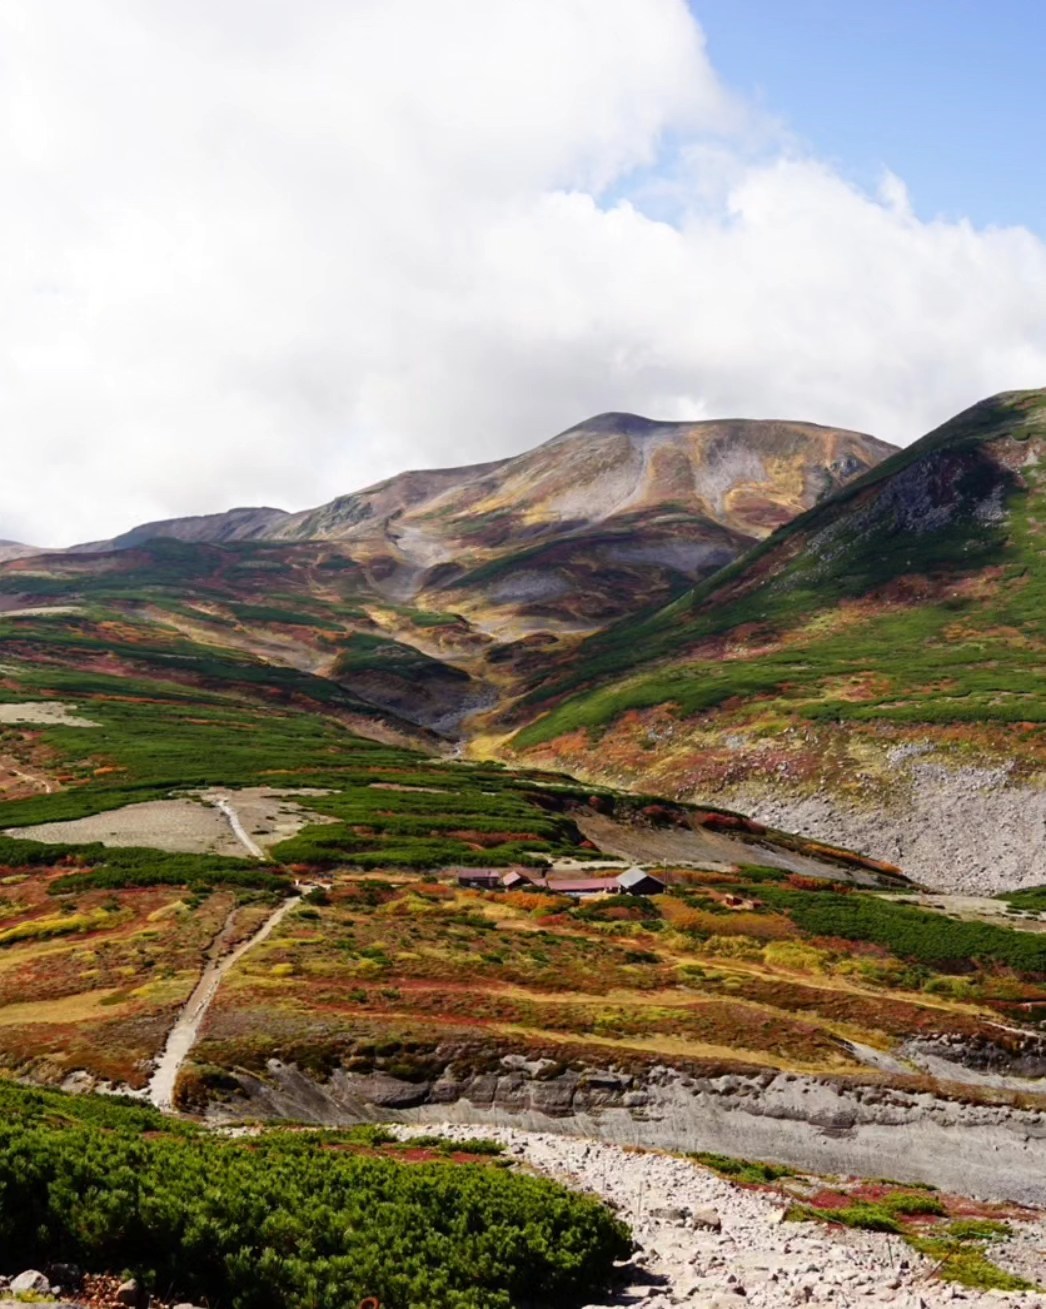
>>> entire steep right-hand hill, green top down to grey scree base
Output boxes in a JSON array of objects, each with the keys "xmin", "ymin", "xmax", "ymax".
[{"xmin": 513, "ymin": 391, "xmax": 1046, "ymax": 889}]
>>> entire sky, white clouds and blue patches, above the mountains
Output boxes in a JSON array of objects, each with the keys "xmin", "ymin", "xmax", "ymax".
[{"xmin": 0, "ymin": 0, "xmax": 1046, "ymax": 546}]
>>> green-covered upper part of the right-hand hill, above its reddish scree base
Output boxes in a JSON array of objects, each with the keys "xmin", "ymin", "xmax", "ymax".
[{"xmin": 514, "ymin": 391, "xmax": 1046, "ymax": 749}]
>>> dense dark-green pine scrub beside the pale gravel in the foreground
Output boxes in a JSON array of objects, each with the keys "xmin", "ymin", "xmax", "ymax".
[{"xmin": 0, "ymin": 1084, "xmax": 631, "ymax": 1309}]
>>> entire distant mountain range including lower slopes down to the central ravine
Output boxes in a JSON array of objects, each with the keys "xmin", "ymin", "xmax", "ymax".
[{"xmin": 0, "ymin": 415, "xmax": 892, "ymax": 738}]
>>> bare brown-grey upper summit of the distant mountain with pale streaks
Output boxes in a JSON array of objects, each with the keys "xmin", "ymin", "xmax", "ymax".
[{"xmin": 65, "ymin": 414, "xmax": 893, "ymax": 635}]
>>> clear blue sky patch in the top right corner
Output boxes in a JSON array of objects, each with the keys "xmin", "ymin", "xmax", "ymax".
[{"xmin": 691, "ymin": 0, "xmax": 1046, "ymax": 237}]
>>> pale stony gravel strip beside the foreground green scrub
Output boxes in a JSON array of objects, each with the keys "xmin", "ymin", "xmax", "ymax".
[{"xmin": 391, "ymin": 1123, "xmax": 1046, "ymax": 1309}]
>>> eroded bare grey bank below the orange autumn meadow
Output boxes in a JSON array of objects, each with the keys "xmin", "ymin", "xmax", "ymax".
[{"xmin": 211, "ymin": 1050, "xmax": 1046, "ymax": 1204}]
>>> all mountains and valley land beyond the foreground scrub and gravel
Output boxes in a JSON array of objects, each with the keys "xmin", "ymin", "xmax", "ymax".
[{"xmin": 0, "ymin": 393, "xmax": 1046, "ymax": 1304}]
